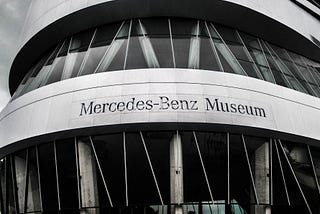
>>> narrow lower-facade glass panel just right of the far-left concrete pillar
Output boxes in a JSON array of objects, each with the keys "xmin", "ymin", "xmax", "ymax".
[{"xmin": 26, "ymin": 148, "xmax": 41, "ymax": 212}]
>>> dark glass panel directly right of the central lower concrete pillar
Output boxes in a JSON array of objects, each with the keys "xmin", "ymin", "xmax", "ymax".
[{"xmin": 181, "ymin": 132, "xmax": 211, "ymax": 203}]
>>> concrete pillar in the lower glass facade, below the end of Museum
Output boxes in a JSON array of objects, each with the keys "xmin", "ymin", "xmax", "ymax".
[{"xmin": 251, "ymin": 142, "xmax": 271, "ymax": 214}]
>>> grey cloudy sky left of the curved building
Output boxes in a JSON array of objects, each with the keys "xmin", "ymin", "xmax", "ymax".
[{"xmin": 0, "ymin": 0, "xmax": 31, "ymax": 111}]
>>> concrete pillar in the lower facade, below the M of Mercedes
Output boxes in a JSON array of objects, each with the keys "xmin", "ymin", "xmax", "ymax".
[{"xmin": 78, "ymin": 141, "xmax": 99, "ymax": 214}]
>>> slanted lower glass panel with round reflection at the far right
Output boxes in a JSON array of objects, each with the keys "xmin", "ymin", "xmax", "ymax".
[{"xmin": 283, "ymin": 142, "xmax": 320, "ymax": 213}]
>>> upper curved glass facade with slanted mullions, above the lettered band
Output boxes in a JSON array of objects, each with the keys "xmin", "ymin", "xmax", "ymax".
[{"xmin": 13, "ymin": 18, "xmax": 320, "ymax": 99}]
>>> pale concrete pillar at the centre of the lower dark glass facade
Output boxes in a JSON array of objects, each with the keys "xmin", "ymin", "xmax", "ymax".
[{"xmin": 170, "ymin": 133, "xmax": 183, "ymax": 214}]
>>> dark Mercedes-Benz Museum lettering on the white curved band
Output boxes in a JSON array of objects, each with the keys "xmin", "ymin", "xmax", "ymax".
[{"xmin": 79, "ymin": 95, "xmax": 268, "ymax": 118}]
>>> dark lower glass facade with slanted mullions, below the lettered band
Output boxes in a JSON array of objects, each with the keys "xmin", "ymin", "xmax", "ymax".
[{"xmin": 0, "ymin": 130, "xmax": 320, "ymax": 214}]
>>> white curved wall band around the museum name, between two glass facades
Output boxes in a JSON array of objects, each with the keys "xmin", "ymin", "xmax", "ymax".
[{"xmin": 0, "ymin": 69, "xmax": 320, "ymax": 147}]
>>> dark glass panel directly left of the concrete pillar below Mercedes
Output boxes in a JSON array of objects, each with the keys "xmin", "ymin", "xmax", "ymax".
[{"xmin": 56, "ymin": 138, "xmax": 79, "ymax": 209}]
